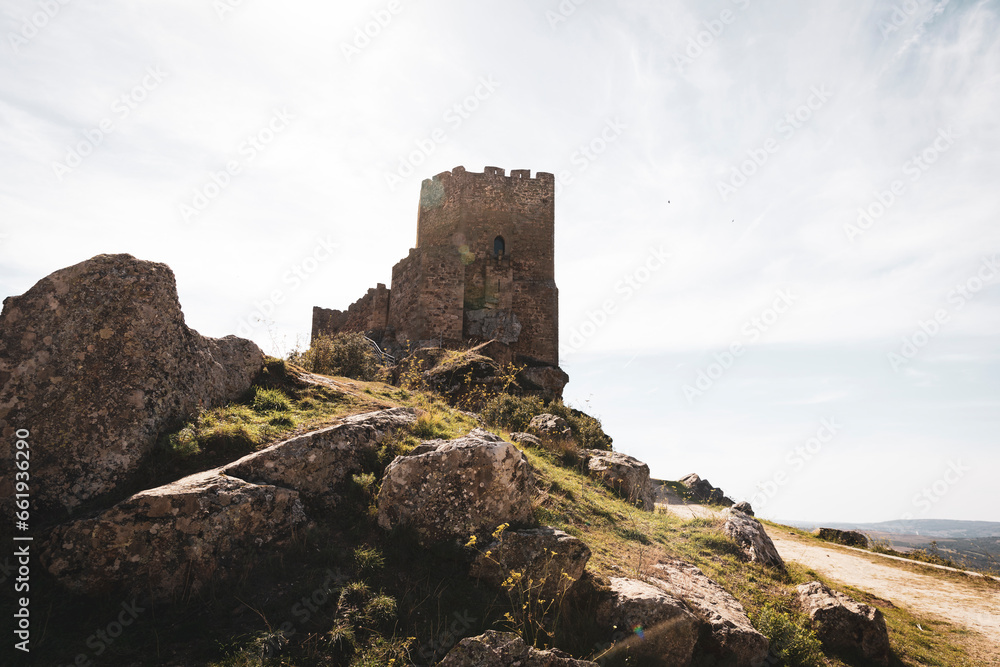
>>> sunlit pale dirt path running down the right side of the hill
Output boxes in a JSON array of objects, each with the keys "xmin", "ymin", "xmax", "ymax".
[{"xmin": 766, "ymin": 526, "xmax": 1000, "ymax": 665}]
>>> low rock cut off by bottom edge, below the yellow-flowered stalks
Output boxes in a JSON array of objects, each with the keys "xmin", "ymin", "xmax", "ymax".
[{"xmin": 438, "ymin": 630, "xmax": 597, "ymax": 667}]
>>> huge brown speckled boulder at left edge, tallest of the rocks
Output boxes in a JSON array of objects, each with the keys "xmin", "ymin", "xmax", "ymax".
[{"xmin": 0, "ymin": 255, "xmax": 264, "ymax": 517}]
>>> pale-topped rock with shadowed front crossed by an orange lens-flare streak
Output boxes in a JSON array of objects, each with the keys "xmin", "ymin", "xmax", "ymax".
[{"xmin": 596, "ymin": 577, "xmax": 700, "ymax": 667}]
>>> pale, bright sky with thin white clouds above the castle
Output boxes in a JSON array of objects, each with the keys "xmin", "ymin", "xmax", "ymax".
[{"xmin": 0, "ymin": 0, "xmax": 1000, "ymax": 521}]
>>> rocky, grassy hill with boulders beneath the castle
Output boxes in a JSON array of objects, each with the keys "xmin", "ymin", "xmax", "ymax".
[{"xmin": 0, "ymin": 255, "xmax": 996, "ymax": 667}]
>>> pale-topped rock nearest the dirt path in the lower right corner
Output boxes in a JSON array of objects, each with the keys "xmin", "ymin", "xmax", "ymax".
[{"xmin": 797, "ymin": 581, "xmax": 890, "ymax": 665}]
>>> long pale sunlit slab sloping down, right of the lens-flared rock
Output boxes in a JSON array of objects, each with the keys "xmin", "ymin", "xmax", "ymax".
[{"xmin": 651, "ymin": 559, "xmax": 768, "ymax": 667}]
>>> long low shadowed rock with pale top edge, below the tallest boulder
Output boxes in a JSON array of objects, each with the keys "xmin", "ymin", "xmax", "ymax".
[{"xmin": 41, "ymin": 470, "xmax": 306, "ymax": 600}]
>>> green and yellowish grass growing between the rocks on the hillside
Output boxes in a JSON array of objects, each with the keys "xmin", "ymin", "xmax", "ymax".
[{"xmin": 25, "ymin": 366, "xmax": 984, "ymax": 667}]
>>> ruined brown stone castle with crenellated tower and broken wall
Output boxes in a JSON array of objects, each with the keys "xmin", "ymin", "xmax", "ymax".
[{"xmin": 312, "ymin": 167, "xmax": 568, "ymax": 394}]
